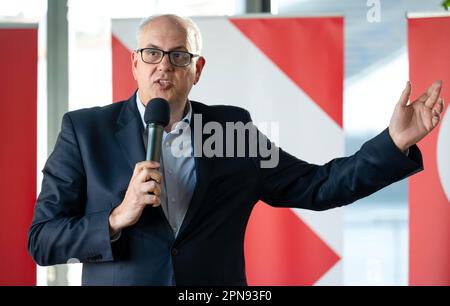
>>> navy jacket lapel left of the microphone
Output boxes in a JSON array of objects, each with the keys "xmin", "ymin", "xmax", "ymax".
[{"xmin": 115, "ymin": 95, "xmax": 145, "ymax": 169}]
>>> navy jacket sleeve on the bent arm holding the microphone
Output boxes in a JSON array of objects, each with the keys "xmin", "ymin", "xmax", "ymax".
[{"xmin": 28, "ymin": 114, "xmax": 113, "ymax": 266}]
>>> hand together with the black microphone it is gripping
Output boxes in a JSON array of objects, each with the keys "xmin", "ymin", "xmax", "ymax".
[{"xmin": 109, "ymin": 98, "xmax": 170, "ymax": 236}]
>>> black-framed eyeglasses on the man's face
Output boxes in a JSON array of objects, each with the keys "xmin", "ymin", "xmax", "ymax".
[{"xmin": 135, "ymin": 48, "xmax": 200, "ymax": 67}]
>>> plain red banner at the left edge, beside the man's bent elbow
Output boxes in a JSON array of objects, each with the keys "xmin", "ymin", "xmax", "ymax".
[{"xmin": 0, "ymin": 28, "xmax": 38, "ymax": 285}]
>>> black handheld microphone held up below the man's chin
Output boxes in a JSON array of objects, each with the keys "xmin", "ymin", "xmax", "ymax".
[{"xmin": 144, "ymin": 98, "xmax": 170, "ymax": 163}]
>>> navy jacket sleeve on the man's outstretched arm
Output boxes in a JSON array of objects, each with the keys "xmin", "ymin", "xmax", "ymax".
[{"xmin": 260, "ymin": 129, "xmax": 423, "ymax": 210}]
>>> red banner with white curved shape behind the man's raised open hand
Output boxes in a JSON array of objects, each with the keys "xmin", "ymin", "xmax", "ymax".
[{"xmin": 408, "ymin": 17, "xmax": 450, "ymax": 285}]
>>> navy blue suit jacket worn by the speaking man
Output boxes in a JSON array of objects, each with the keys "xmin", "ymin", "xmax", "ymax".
[{"xmin": 28, "ymin": 96, "xmax": 422, "ymax": 285}]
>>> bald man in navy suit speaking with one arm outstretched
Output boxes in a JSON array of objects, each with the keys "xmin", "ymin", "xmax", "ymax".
[{"xmin": 28, "ymin": 15, "xmax": 444, "ymax": 285}]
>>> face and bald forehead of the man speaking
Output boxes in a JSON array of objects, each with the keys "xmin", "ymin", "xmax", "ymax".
[{"xmin": 132, "ymin": 18, "xmax": 205, "ymax": 107}]
